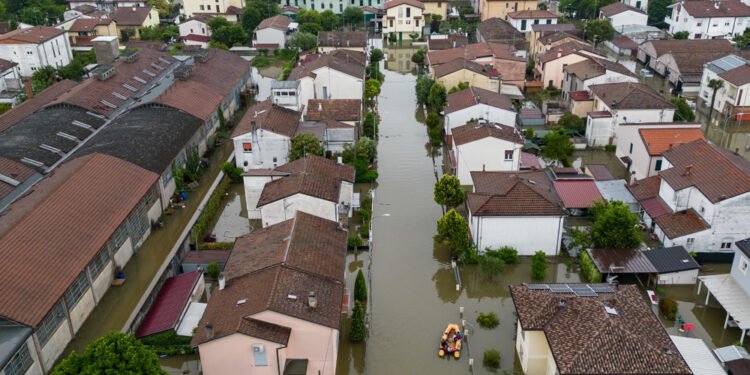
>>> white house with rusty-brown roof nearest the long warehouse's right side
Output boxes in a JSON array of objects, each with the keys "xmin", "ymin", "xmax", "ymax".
[{"xmin": 232, "ymin": 100, "xmax": 302, "ymax": 171}]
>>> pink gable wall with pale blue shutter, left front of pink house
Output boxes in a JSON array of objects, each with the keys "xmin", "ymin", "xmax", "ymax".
[{"xmin": 198, "ymin": 333, "xmax": 286, "ymax": 375}]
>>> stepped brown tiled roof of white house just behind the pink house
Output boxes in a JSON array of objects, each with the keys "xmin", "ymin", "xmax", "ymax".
[{"xmin": 258, "ymin": 155, "xmax": 354, "ymax": 207}]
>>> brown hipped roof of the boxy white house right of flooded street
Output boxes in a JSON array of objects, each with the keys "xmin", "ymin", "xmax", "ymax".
[{"xmin": 466, "ymin": 171, "xmax": 565, "ymax": 216}]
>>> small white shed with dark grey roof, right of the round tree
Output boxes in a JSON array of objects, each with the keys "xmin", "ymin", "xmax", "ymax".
[{"xmin": 644, "ymin": 246, "xmax": 701, "ymax": 285}]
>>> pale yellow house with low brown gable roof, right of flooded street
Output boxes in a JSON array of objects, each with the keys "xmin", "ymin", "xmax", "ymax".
[{"xmin": 433, "ymin": 57, "xmax": 500, "ymax": 92}]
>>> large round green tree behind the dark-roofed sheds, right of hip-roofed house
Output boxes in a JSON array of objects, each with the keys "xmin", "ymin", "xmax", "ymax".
[{"xmin": 589, "ymin": 201, "xmax": 641, "ymax": 249}]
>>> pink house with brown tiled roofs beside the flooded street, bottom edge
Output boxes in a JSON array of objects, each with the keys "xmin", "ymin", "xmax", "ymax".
[{"xmin": 192, "ymin": 211, "xmax": 347, "ymax": 375}]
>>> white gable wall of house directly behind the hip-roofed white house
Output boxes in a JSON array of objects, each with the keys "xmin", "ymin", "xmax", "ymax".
[{"xmin": 453, "ymin": 137, "xmax": 523, "ymax": 185}]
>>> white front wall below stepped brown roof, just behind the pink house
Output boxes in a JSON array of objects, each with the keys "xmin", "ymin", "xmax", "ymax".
[{"xmin": 260, "ymin": 194, "xmax": 338, "ymax": 228}]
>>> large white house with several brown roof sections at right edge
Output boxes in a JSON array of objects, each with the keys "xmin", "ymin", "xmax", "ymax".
[{"xmin": 653, "ymin": 139, "xmax": 750, "ymax": 255}]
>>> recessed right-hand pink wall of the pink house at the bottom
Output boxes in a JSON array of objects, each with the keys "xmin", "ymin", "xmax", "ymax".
[{"xmin": 252, "ymin": 311, "xmax": 339, "ymax": 375}]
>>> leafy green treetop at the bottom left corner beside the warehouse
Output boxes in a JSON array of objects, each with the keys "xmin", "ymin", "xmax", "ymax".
[{"xmin": 52, "ymin": 331, "xmax": 167, "ymax": 375}]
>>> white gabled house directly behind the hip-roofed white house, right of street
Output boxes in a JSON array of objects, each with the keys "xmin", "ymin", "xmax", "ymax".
[{"xmin": 451, "ymin": 120, "xmax": 523, "ymax": 185}]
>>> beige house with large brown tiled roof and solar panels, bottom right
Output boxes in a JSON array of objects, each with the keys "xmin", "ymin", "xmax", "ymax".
[{"xmin": 510, "ymin": 284, "xmax": 693, "ymax": 375}]
